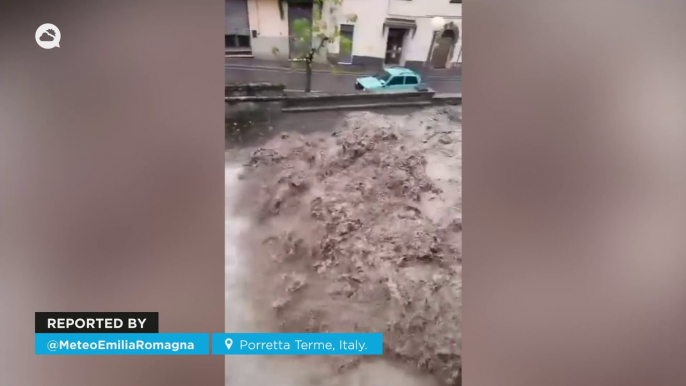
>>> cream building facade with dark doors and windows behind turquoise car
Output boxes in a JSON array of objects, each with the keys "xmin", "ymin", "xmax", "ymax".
[{"xmin": 225, "ymin": 0, "xmax": 462, "ymax": 68}]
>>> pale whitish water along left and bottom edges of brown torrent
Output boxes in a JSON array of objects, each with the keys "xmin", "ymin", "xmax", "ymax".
[{"xmin": 224, "ymin": 164, "xmax": 435, "ymax": 386}]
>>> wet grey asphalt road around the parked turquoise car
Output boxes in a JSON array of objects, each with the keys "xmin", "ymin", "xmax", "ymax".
[{"xmin": 225, "ymin": 67, "xmax": 462, "ymax": 93}]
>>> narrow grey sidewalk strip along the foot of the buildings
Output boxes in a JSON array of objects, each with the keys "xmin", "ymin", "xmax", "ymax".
[{"xmin": 225, "ymin": 57, "xmax": 462, "ymax": 78}]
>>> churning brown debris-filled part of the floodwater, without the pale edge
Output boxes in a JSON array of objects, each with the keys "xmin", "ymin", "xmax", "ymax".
[{"xmin": 239, "ymin": 108, "xmax": 462, "ymax": 385}]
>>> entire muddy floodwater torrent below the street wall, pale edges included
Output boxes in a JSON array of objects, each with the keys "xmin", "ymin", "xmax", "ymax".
[{"xmin": 225, "ymin": 108, "xmax": 462, "ymax": 386}]
